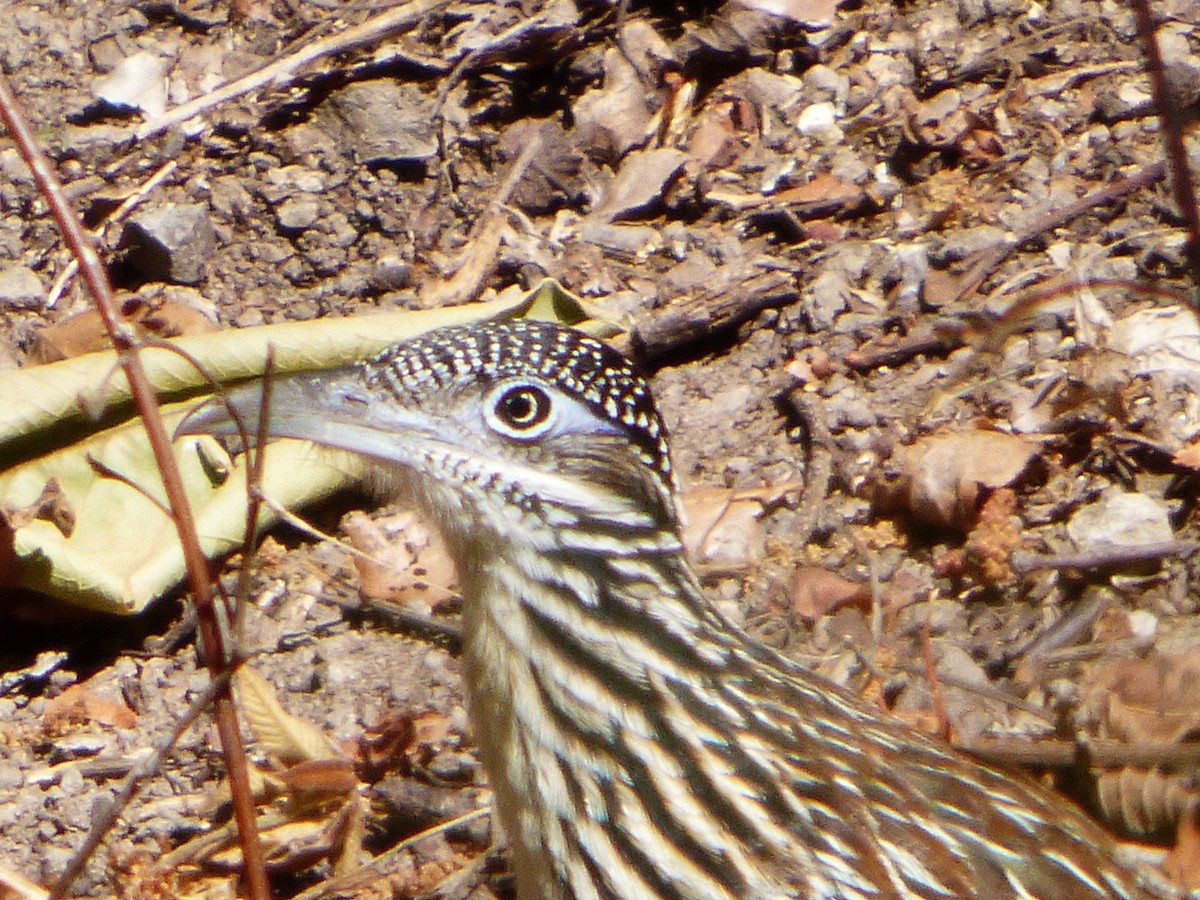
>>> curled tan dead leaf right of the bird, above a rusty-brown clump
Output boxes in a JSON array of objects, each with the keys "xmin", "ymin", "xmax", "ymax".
[{"xmin": 875, "ymin": 430, "xmax": 1038, "ymax": 528}]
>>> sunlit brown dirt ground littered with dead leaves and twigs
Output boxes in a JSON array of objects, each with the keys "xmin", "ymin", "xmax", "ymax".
[{"xmin": 0, "ymin": 0, "xmax": 1200, "ymax": 898}]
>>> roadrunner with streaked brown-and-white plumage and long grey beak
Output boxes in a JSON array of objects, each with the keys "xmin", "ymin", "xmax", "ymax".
[{"xmin": 184, "ymin": 320, "xmax": 1151, "ymax": 900}]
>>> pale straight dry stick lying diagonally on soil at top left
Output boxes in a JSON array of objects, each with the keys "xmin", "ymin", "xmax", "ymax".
[{"xmin": 133, "ymin": 0, "xmax": 449, "ymax": 140}]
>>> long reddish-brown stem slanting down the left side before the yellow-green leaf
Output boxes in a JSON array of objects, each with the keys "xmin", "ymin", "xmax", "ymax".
[{"xmin": 0, "ymin": 74, "xmax": 270, "ymax": 900}]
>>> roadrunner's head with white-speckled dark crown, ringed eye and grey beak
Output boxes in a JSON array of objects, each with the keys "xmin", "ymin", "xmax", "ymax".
[{"xmin": 179, "ymin": 320, "xmax": 678, "ymax": 553}]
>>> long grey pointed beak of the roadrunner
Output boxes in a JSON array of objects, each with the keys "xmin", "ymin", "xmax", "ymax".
[{"xmin": 175, "ymin": 368, "xmax": 434, "ymax": 460}]
